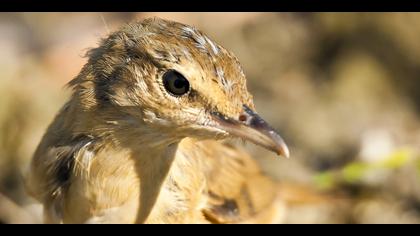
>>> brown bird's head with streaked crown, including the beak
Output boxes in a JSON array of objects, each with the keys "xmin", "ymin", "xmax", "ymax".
[{"xmin": 70, "ymin": 18, "xmax": 289, "ymax": 157}]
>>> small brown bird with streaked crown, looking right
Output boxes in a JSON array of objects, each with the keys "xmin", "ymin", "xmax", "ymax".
[{"xmin": 27, "ymin": 18, "xmax": 289, "ymax": 223}]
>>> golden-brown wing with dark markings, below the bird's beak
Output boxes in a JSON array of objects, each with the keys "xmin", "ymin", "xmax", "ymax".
[{"xmin": 180, "ymin": 140, "xmax": 284, "ymax": 223}]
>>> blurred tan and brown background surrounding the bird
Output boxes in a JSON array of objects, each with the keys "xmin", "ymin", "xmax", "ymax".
[{"xmin": 0, "ymin": 13, "xmax": 420, "ymax": 223}]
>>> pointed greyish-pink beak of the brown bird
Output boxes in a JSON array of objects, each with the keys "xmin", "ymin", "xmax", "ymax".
[{"xmin": 212, "ymin": 105, "xmax": 289, "ymax": 158}]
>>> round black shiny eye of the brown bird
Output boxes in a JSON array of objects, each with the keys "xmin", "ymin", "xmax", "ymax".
[{"xmin": 162, "ymin": 70, "xmax": 190, "ymax": 96}]
